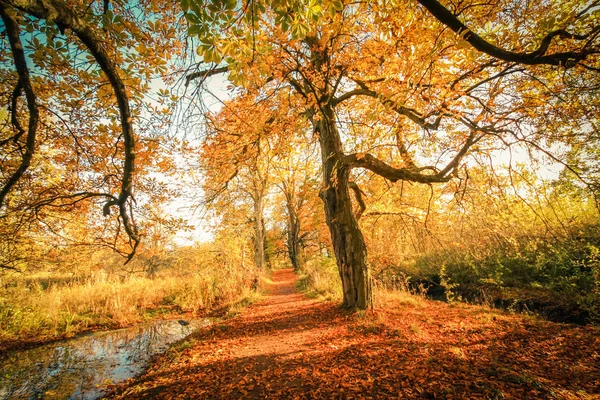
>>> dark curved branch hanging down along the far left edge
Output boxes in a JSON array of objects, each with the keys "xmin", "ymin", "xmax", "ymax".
[{"xmin": 0, "ymin": 3, "xmax": 39, "ymax": 207}]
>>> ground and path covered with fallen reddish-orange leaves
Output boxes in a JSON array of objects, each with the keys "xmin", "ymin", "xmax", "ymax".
[{"xmin": 110, "ymin": 270, "xmax": 600, "ymax": 399}]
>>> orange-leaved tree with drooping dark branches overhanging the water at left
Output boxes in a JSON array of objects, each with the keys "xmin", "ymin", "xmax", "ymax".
[{"xmin": 0, "ymin": 0, "xmax": 181, "ymax": 268}]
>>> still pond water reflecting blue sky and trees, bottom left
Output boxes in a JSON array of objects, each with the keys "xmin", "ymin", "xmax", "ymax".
[{"xmin": 0, "ymin": 321, "xmax": 208, "ymax": 399}]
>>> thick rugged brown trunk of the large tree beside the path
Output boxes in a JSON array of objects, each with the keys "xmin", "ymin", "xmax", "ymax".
[{"xmin": 314, "ymin": 105, "xmax": 373, "ymax": 309}]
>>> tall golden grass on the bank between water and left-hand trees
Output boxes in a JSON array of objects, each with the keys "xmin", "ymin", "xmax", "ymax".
[{"xmin": 0, "ymin": 242, "xmax": 257, "ymax": 348}]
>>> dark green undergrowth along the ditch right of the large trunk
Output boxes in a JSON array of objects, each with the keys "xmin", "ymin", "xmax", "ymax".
[{"xmin": 375, "ymin": 226, "xmax": 600, "ymax": 323}]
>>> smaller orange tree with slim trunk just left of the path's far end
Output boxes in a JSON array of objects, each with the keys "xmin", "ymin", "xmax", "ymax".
[{"xmin": 199, "ymin": 96, "xmax": 284, "ymax": 270}]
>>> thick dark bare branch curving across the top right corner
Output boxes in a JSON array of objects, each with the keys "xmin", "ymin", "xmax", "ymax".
[{"xmin": 418, "ymin": 0, "xmax": 600, "ymax": 67}]
